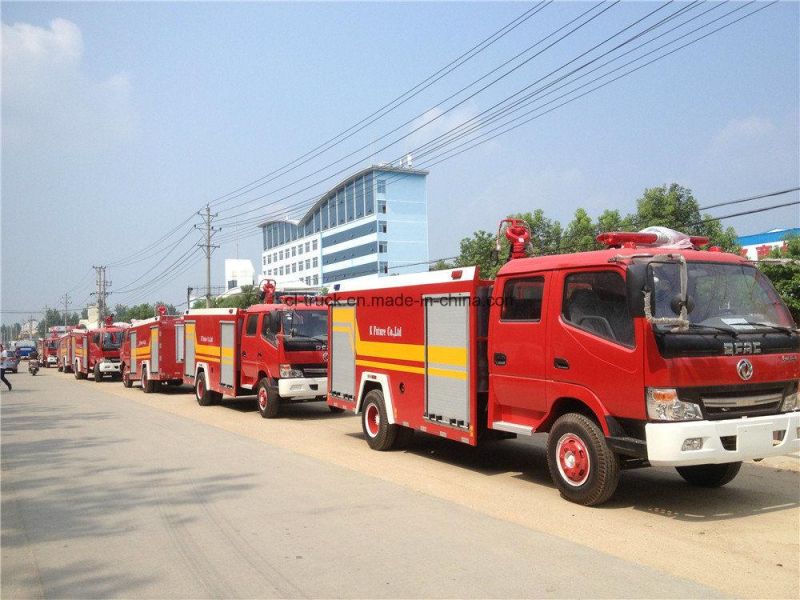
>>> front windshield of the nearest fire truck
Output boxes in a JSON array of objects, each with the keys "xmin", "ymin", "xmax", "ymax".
[{"xmin": 650, "ymin": 262, "xmax": 795, "ymax": 331}]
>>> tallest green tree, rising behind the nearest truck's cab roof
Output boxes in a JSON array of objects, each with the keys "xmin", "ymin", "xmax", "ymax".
[{"xmin": 630, "ymin": 183, "xmax": 739, "ymax": 253}]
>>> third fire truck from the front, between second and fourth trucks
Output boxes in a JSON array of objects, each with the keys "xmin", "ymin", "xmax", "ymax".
[{"xmin": 120, "ymin": 306, "xmax": 183, "ymax": 394}]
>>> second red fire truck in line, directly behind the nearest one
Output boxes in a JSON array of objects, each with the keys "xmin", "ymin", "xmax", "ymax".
[{"xmin": 183, "ymin": 282, "xmax": 330, "ymax": 418}]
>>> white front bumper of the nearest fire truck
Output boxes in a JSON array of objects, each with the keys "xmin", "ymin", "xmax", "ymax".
[{"xmin": 645, "ymin": 412, "xmax": 800, "ymax": 467}]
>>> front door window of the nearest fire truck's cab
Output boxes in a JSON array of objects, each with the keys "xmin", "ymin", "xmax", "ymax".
[{"xmin": 561, "ymin": 271, "xmax": 634, "ymax": 346}]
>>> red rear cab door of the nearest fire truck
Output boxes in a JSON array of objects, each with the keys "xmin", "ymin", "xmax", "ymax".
[{"xmin": 488, "ymin": 273, "xmax": 551, "ymax": 426}]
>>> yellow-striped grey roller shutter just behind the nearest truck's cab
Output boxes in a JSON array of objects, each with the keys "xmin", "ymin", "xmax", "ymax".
[{"xmin": 423, "ymin": 294, "xmax": 470, "ymax": 429}]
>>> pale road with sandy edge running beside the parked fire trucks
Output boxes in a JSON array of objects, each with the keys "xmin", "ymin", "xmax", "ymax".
[{"xmin": 0, "ymin": 370, "xmax": 800, "ymax": 598}]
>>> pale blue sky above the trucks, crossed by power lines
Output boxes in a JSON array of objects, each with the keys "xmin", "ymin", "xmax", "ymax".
[{"xmin": 2, "ymin": 2, "xmax": 800, "ymax": 322}]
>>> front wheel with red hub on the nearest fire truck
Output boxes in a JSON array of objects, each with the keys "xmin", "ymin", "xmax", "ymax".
[{"xmin": 547, "ymin": 413, "xmax": 619, "ymax": 506}]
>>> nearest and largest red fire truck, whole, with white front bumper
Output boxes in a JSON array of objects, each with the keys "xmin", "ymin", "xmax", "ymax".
[{"xmin": 328, "ymin": 224, "xmax": 800, "ymax": 505}]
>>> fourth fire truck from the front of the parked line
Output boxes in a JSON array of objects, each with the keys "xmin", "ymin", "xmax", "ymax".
[{"xmin": 70, "ymin": 317, "xmax": 125, "ymax": 383}]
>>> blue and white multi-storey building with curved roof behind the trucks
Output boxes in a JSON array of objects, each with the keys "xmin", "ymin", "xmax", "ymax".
[{"xmin": 259, "ymin": 165, "xmax": 428, "ymax": 287}]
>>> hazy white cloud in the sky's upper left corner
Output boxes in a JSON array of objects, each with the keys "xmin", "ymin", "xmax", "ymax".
[{"xmin": 2, "ymin": 19, "xmax": 136, "ymax": 154}]
